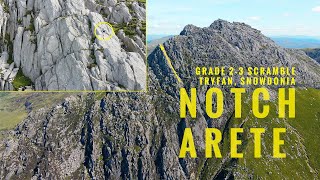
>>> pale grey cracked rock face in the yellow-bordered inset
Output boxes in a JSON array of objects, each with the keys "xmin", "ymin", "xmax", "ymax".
[{"xmin": 0, "ymin": 0, "xmax": 146, "ymax": 90}]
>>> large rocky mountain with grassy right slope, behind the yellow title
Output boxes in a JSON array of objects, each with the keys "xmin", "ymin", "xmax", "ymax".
[{"xmin": 0, "ymin": 20, "xmax": 320, "ymax": 179}]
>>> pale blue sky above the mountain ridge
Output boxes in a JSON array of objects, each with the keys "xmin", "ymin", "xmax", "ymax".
[{"xmin": 147, "ymin": 0, "xmax": 320, "ymax": 37}]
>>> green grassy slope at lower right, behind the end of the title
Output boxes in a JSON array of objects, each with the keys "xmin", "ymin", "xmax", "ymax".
[{"xmin": 234, "ymin": 89, "xmax": 320, "ymax": 179}]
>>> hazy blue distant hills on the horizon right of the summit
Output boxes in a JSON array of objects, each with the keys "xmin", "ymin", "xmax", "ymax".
[{"xmin": 271, "ymin": 36, "xmax": 320, "ymax": 49}]
